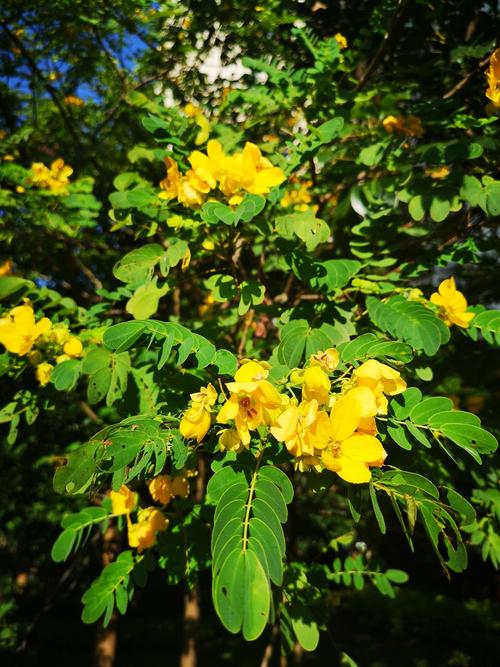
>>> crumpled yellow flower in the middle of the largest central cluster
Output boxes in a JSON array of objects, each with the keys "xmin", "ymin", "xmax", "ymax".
[{"xmin": 271, "ymin": 399, "xmax": 330, "ymax": 465}]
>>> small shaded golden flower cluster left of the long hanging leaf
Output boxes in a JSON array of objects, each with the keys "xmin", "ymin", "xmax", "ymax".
[{"xmin": 110, "ymin": 475, "xmax": 189, "ymax": 553}]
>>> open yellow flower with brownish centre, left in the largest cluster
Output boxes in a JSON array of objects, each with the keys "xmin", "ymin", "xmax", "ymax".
[{"xmin": 217, "ymin": 361, "xmax": 282, "ymax": 447}]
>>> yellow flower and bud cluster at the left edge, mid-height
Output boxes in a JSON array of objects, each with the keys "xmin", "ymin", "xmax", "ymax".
[{"xmin": 0, "ymin": 302, "xmax": 83, "ymax": 387}]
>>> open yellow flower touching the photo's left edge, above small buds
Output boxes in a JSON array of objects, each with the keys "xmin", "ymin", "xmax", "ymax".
[{"xmin": 0, "ymin": 304, "xmax": 52, "ymax": 357}]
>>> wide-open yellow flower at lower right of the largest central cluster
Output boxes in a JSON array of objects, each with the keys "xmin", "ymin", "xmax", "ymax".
[{"xmin": 321, "ymin": 392, "xmax": 387, "ymax": 484}]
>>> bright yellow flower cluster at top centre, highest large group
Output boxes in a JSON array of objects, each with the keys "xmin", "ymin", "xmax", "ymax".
[{"xmin": 159, "ymin": 139, "xmax": 285, "ymax": 208}]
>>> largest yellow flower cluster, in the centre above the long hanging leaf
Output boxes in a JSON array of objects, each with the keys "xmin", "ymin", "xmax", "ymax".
[{"xmin": 181, "ymin": 358, "xmax": 406, "ymax": 484}]
